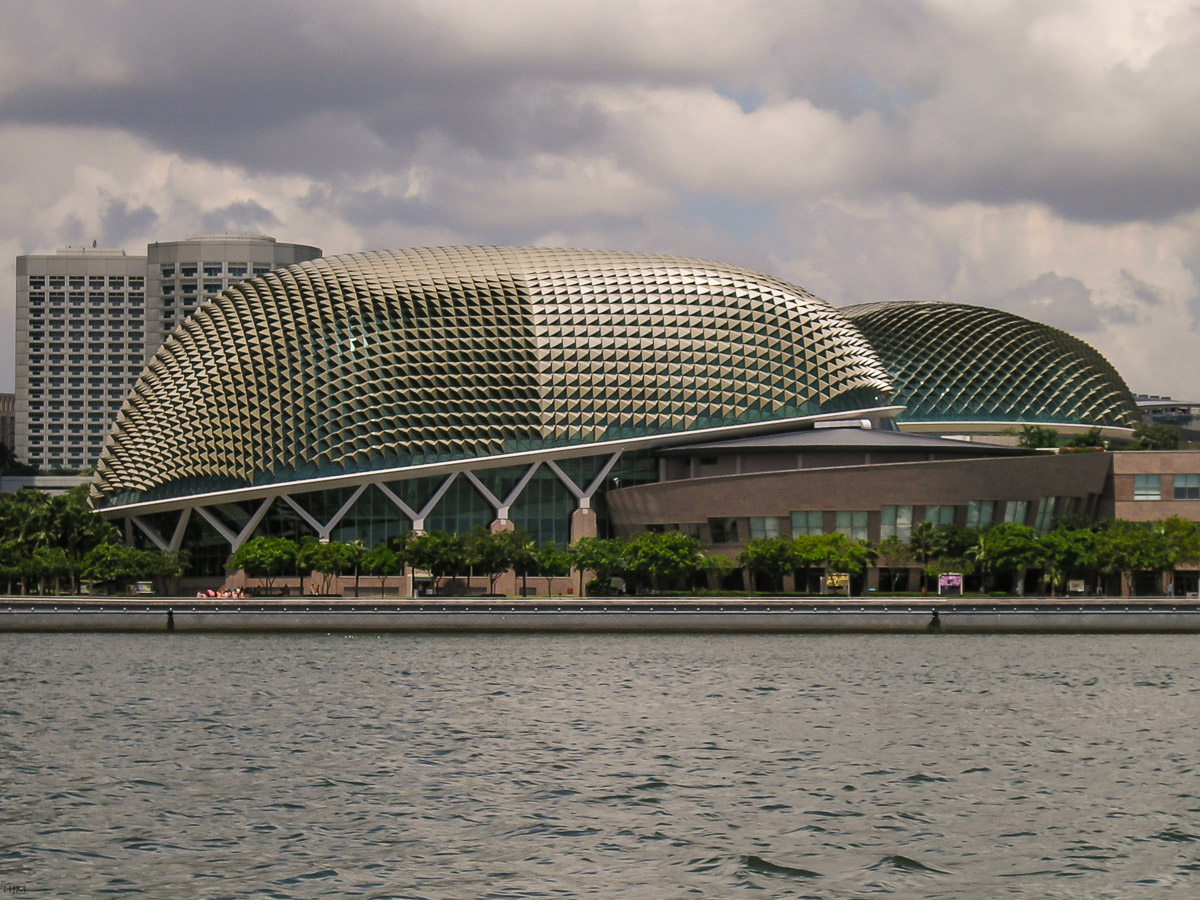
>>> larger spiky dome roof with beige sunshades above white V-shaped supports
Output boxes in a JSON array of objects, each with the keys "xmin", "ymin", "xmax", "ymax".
[{"xmin": 92, "ymin": 247, "xmax": 890, "ymax": 505}]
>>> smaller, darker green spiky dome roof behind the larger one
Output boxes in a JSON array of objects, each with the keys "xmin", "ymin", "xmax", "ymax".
[{"xmin": 842, "ymin": 301, "xmax": 1138, "ymax": 428}]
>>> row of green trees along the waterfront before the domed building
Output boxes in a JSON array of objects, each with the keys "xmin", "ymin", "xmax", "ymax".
[{"xmin": 0, "ymin": 487, "xmax": 1200, "ymax": 596}]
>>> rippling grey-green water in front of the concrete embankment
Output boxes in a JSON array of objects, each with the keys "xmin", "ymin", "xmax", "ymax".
[{"xmin": 0, "ymin": 635, "xmax": 1200, "ymax": 900}]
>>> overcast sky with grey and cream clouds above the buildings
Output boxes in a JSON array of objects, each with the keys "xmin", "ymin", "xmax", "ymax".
[{"xmin": 0, "ymin": 0, "xmax": 1200, "ymax": 400}]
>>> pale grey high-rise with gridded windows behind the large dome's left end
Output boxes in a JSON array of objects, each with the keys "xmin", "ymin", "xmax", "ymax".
[{"xmin": 14, "ymin": 234, "xmax": 320, "ymax": 469}]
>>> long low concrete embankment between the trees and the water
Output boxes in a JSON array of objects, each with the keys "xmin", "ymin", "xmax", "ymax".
[{"xmin": 0, "ymin": 598, "xmax": 1200, "ymax": 634}]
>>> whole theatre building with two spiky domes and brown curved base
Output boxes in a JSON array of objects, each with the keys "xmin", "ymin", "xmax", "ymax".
[{"xmin": 91, "ymin": 247, "xmax": 1200, "ymax": 585}]
